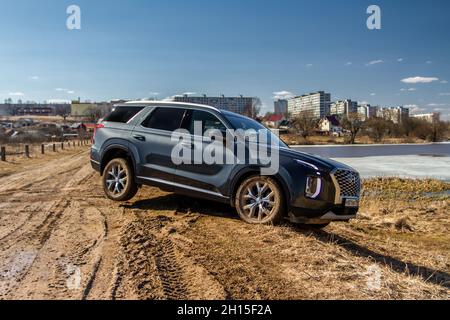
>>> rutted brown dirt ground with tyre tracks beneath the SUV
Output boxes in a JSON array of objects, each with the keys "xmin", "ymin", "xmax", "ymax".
[{"xmin": 0, "ymin": 150, "xmax": 450, "ymax": 299}]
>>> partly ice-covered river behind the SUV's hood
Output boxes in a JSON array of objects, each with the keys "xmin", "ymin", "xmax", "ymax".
[{"xmin": 293, "ymin": 143, "xmax": 450, "ymax": 181}]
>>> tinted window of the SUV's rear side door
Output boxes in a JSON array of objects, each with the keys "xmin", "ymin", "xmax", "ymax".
[{"xmin": 142, "ymin": 107, "xmax": 186, "ymax": 131}]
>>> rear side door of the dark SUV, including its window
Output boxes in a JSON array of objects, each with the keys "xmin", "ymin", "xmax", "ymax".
[{"xmin": 131, "ymin": 106, "xmax": 186, "ymax": 182}]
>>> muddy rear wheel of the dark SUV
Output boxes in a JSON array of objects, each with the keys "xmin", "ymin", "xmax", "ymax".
[{"xmin": 102, "ymin": 158, "xmax": 138, "ymax": 202}]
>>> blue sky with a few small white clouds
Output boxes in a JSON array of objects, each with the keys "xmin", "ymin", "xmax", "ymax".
[{"xmin": 0, "ymin": 0, "xmax": 450, "ymax": 117}]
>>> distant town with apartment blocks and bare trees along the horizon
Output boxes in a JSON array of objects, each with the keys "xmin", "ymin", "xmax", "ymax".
[{"xmin": 0, "ymin": 91, "xmax": 449, "ymax": 143}]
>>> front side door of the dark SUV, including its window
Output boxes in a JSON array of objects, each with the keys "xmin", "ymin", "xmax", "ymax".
[{"xmin": 172, "ymin": 110, "xmax": 234, "ymax": 194}]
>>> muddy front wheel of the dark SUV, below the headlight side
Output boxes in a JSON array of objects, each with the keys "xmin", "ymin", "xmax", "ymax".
[{"xmin": 235, "ymin": 176, "xmax": 285, "ymax": 225}]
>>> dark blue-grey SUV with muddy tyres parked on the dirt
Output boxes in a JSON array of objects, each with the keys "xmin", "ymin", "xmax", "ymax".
[{"xmin": 91, "ymin": 101, "xmax": 360, "ymax": 227}]
